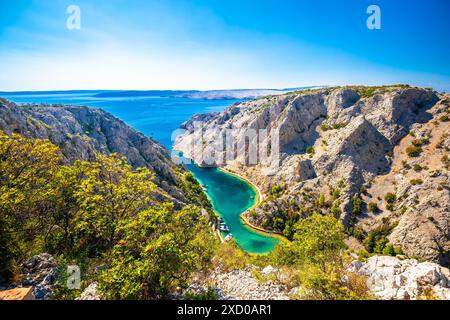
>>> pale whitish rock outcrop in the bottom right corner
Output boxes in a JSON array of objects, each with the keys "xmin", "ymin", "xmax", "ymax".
[{"xmin": 349, "ymin": 256, "xmax": 450, "ymax": 300}]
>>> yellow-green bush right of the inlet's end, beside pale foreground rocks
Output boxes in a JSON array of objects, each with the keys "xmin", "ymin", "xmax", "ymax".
[{"xmin": 270, "ymin": 213, "xmax": 370, "ymax": 300}]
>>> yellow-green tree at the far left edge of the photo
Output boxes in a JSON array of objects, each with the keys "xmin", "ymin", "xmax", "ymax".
[{"xmin": 0, "ymin": 132, "xmax": 62, "ymax": 280}]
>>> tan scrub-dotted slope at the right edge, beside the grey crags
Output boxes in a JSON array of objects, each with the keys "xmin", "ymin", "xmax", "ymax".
[{"xmin": 358, "ymin": 98, "xmax": 450, "ymax": 265}]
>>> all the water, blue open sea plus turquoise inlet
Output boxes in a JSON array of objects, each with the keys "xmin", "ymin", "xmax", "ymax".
[{"xmin": 2, "ymin": 92, "xmax": 279, "ymax": 253}]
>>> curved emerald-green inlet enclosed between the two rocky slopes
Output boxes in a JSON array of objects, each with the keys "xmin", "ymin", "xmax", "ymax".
[{"xmin": 187, "ymin": 164, "xmax": 280, "ymax": 253}]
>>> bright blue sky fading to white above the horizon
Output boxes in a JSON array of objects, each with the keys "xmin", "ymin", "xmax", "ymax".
[{"xmin": 0, "ymin": 0, "xmax": 450, "ymax": 92}]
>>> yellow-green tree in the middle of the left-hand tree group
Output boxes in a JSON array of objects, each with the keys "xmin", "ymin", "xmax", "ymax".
[{"xmin": 70, "ymin": 154, "xmax": 156, "ymax": 251}]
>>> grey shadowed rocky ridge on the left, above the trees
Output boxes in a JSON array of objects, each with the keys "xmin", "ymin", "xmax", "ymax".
[{"xmin": 0, "ymin": 99, "xmax": 186, "ymax": 205}]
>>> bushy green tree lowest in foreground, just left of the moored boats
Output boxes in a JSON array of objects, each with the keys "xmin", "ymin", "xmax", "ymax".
[{"xmin": 100, "ymin": 204, "xmax": 214, "ymax": 299}]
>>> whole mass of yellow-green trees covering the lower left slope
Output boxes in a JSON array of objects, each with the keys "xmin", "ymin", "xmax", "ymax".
[{"xmin": 0, "ymin": 133, "xmax": 214, "ymax": 299}]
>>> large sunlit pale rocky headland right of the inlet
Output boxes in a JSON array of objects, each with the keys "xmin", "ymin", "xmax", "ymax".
[{"xmin": 175, "ymin": 86, "xmax": 450, "ymax": 262}]
